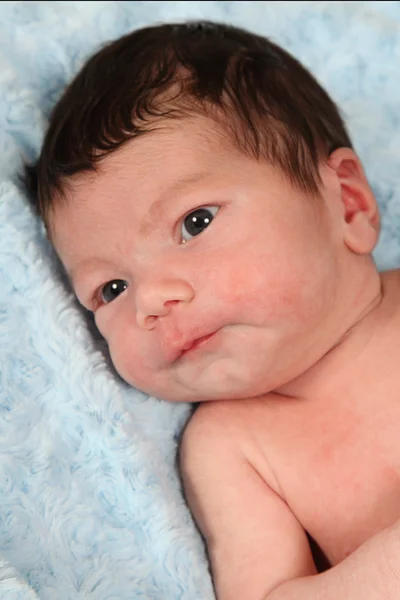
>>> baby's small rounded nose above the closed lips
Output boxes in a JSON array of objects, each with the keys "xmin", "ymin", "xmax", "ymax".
[{"xmin": 136, "ymin": 280, "xmax": 194, "ymax": 330}]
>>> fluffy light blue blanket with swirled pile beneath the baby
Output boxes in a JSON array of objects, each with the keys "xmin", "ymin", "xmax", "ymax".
[{"xmin": 0, "ymin": 1, "xmax": 400, "ymax": 600}]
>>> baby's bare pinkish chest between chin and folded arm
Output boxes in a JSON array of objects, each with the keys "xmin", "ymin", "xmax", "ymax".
[{"xmin": 264, "ymin": 396, "xmax": 400, "ymax": 564}]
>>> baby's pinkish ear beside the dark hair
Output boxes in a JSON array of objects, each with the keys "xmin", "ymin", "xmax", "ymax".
[{"xmin": 328, "ymin": 148, "xmax": 380, "ymax": 254}]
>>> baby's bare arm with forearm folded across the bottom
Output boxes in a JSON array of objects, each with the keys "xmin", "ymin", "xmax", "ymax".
[{"xmin": 181, "ymin": 403, "xmax": 400, "ymax": 600}]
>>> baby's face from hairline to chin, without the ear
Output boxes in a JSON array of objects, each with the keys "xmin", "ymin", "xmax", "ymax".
[{"xmin": 52, "ymin": 118, "xmax": 346, "ymax": 401}]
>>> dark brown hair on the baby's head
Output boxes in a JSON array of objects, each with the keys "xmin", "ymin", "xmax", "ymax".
[{"xmin": 26, "ymin": 21, "xmax": 351, "ymax": 222}]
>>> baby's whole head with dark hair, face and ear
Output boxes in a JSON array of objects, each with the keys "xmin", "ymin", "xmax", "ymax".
[{"xmin": 25, "ymin": 23, "xmax": 379, "ymax": 401}]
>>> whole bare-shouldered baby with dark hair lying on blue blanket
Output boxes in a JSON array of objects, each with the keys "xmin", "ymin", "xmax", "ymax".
[{"xmin": 25, "ymin": 22, "xmax": 400, "ymax": 600}]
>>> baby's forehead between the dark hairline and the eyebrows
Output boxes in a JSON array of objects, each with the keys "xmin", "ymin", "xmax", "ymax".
[{"xmin": 50, "ymin": 117, "xmax": 245, "ymax": 258}]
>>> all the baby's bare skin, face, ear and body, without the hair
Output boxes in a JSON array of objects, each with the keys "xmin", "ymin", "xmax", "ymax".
[{"xmin": 50, "ymin": 117, "xmax": 400, "ymax": 600}]
